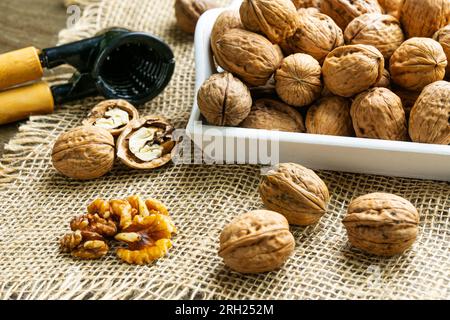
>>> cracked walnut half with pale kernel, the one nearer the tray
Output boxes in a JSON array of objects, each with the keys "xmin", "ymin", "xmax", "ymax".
[{"xmin": 117, "ymin": 115, "xmax": 175, "ymax": 169}]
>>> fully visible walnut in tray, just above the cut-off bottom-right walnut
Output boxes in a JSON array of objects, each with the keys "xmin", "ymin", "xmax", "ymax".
[{"xmin": 390, "ymin": 38, "xmax": 447, "ymax": 91}]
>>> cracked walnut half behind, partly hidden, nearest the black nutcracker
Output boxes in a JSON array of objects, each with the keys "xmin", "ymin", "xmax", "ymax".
[{"xmin": 83, "ymin": 100, "xmax": 139, "ymax": 136}]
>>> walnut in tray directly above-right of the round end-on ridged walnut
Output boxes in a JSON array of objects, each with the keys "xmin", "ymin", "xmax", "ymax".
[{"xmin": 281, "ymin": 11, "xmax": 344, "ymax": 64}]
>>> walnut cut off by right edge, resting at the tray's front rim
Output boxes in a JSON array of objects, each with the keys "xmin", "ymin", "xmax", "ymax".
[{"xmin": 409, "ymin": 81, "xmax": 450, "ymax": 145}]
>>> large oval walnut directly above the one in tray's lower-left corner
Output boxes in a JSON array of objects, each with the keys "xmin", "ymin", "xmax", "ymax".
[{"xmin": 214, "ymin": 29, "xmax": 283, "ymax": 86}]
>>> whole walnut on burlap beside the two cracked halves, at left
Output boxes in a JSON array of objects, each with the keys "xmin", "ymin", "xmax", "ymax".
[{"xmin": 52, "ymin": 126, "xmax": 114, "ymax": 180}]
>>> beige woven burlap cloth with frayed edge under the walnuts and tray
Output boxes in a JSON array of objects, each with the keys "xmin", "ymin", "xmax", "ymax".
[{"xmin": 0, "ymin": 0, "xmax": 450, "ymax": 299}]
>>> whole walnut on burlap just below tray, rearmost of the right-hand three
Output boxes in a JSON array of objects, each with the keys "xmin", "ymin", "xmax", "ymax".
[{"xmin": 259, "ymin": 163, "xmax": 330, "ymax": 226}]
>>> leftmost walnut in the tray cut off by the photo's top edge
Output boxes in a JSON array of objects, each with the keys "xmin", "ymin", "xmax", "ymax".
[{"xmin": 239, "ymin": 0, "xmax": 298, "ymax": 43}]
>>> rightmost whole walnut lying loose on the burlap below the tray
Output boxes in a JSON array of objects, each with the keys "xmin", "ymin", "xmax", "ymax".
[{"xmin": 343, "ymin": 193, "xmax": 419, "ymax": 256}]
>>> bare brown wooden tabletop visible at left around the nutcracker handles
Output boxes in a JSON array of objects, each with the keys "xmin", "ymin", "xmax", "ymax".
[{"xmin": 0, "ymin": 0, "xmax": 66, "ymax": 155}]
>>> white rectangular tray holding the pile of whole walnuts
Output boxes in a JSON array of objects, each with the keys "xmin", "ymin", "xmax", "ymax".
[{"xmin": 187, "ymin": 0, "xmax": 450, "ymax": 181}]
